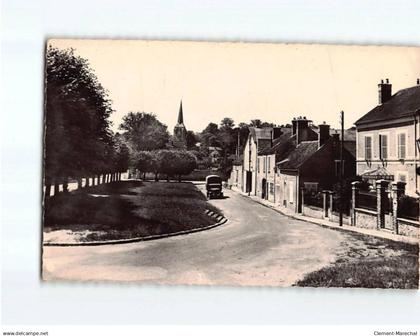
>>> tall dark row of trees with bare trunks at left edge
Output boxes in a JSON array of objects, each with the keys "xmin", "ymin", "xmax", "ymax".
[{"xmin": 44, "ymin": 46, "xmax": 129, "ymax": 195}]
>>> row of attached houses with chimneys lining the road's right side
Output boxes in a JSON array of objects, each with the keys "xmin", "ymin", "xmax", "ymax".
[{"xmin": 229, "ymin": 117, "xmax": 356, "ymax": 212}]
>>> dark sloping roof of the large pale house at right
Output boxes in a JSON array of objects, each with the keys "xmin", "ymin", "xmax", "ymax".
[{"xmin": 355, "ymin": 85, "xmax": 420, "ymax": 125}]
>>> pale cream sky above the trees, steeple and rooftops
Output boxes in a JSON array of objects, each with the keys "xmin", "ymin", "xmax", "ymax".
[{"xmin": 49, "ymin": 40, "xmax": 420, "ymax": 132}]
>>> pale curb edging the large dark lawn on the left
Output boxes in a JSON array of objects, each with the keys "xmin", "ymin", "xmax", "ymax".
[{"xmin": 42, "ymin": 209, "xmax": 228, "ymax": 247}]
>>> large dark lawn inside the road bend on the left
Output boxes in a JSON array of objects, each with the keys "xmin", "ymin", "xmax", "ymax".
[{"xmin": 44, "ymin": 181, "xmax": 220, "ymax": 241}]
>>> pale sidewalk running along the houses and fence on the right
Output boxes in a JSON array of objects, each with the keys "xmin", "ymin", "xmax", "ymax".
[{"xmin": 231, "ymin": 188, "xmax": 419, "ymax": 244}]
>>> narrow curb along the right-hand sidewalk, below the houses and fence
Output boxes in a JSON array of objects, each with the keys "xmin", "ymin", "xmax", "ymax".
[{"xmin": 237, "ymin": 192, "xmax": 419, "ymax": 245}]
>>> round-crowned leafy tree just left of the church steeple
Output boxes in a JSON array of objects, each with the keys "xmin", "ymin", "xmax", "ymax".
[{"xmin": 119, "ymin": 112, "xmax": 169, "ymax": 151}]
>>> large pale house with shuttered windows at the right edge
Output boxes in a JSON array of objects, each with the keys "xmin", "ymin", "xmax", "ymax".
[{"xmin": 355, "ymin": 79, "xmax": 420, "ymax": 197}]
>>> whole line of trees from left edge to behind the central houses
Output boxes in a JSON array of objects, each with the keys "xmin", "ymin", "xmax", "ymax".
[{"xmin": 44, "ymin": 46, "xmax": 280, "ymax": 195}]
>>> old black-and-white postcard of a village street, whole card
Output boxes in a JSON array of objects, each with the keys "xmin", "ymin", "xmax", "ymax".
[{"xmin": 42, "ymin": 39, "xmax": 420, "ymax": 289}]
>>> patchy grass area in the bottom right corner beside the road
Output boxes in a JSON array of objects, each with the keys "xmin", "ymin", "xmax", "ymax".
[{"xmin": 296, "ymin": 233, "xmax": 419, "ymax": 289}]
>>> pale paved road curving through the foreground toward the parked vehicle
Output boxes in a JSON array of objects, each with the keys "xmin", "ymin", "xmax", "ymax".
[{"xmin": 43, "ymin": 186, "xmax": 347, "ymax": 286}]
